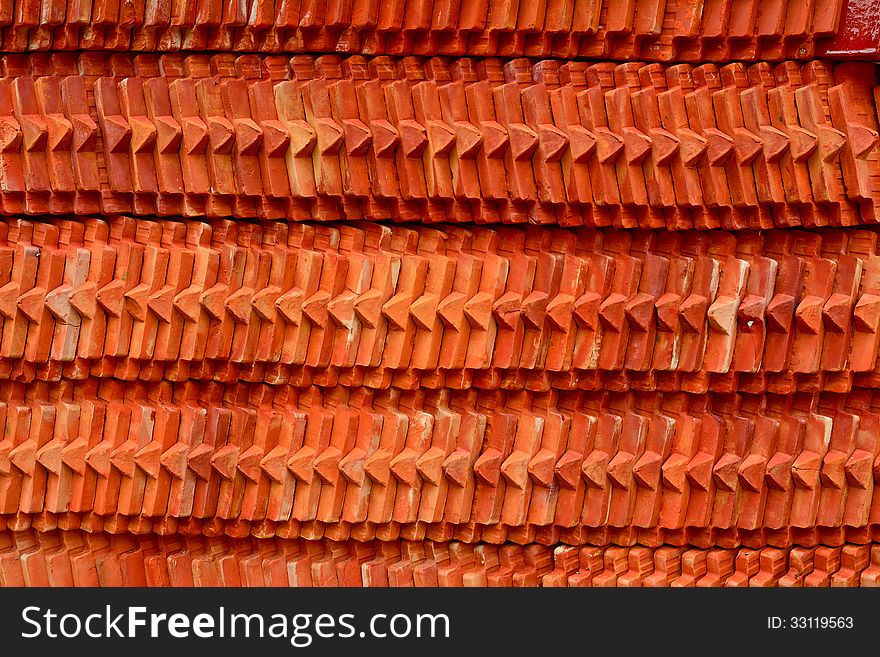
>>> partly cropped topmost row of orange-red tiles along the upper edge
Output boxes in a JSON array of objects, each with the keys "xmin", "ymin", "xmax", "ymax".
[{"xmin": 0, "ymin": 0, "xmax": 844, "ymax": 61}]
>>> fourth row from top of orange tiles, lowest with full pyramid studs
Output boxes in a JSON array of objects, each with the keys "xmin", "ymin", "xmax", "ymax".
[{"xmin": 0, "ymin": 380, "xmax": 880, "ymax": 543}]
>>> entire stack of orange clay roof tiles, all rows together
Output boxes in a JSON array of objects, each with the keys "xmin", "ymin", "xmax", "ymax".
[{"xmin": 0, "ymin": 0, "xmax": 880, "ymax": 586}]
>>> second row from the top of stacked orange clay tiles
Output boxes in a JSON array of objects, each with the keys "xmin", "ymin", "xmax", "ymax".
[{"xmin": 0, "ymin": 53, "xmax": 868, "ymax": 229}]
